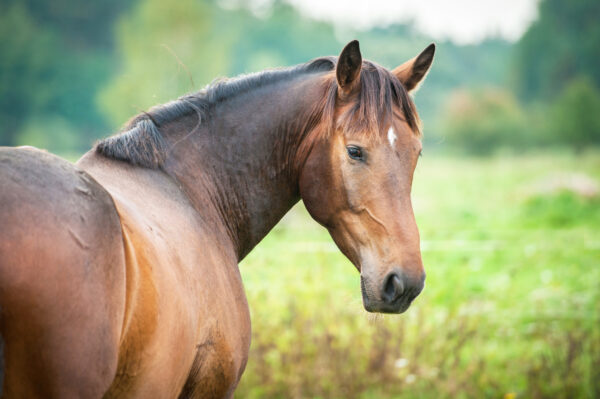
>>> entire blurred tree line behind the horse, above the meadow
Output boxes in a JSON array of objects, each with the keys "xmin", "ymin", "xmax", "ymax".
[{"xmin": 0, "ymin": 0, "xmax": 600, "ymax": 154}]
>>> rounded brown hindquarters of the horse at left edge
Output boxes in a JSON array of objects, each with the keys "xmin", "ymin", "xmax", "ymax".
[{"xmin": 0, "ymin": 148, "xmax": 125, "ymax": 397}]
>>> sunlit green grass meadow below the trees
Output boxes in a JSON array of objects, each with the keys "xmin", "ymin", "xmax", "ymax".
[{"xmin": 236, "ymin": 152, "xmax": 600, "ymax": 398}]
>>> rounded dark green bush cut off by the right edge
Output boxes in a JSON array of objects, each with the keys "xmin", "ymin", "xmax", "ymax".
[{"xmin": 548, "ymin": 77, "xmax": 600, "ymax": 151}]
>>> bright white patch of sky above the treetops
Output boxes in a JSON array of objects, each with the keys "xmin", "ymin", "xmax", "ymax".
[{"xmin": 284, "ymin": 0, "xmax": 539, "ymax": 44}]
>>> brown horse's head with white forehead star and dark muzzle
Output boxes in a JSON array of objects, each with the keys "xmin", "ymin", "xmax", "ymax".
[{"xmin": 299, "ymin": 41, "xmax": 435, "ymax": 313}]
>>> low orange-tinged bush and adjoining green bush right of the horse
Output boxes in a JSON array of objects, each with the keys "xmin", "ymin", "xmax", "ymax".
[{"xmin": 441, "ymin": 77, "xmax": 600, "ymax": 155}]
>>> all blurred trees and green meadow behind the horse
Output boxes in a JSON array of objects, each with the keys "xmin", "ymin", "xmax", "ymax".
[{"xmin": 0, "ymin": 0, "xmax": 600, "ymax": 398}]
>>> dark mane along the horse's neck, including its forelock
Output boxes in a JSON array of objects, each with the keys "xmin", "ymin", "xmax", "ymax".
[{"xmin": 94, "ymin": 57, "xmax": 420, "ymax": 169}]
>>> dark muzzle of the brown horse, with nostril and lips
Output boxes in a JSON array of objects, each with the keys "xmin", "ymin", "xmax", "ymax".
[{"xmin": 361, "ymin": 268, "xmax": 425, "ymax": 313}]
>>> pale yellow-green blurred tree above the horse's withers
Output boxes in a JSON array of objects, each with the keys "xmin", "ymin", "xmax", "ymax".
[{"xmin": 98, "ymin": 0, "xmax": 236, "ymax": 126}]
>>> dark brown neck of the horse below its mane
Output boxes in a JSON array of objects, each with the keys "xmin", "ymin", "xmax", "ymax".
[{"xmin": 166, "ymin": 76, "xmax": 316, "ymax": 260}]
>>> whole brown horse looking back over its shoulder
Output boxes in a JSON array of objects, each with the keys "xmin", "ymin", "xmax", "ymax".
[{"xmin": 0, "ymin": 41, "xmax": 434, "ymax": 398}]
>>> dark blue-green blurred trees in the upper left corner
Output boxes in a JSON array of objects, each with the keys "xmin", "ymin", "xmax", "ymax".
[{"xmin": 0, "ymin": 0, "xmax": 129, "ymax": 151}]
